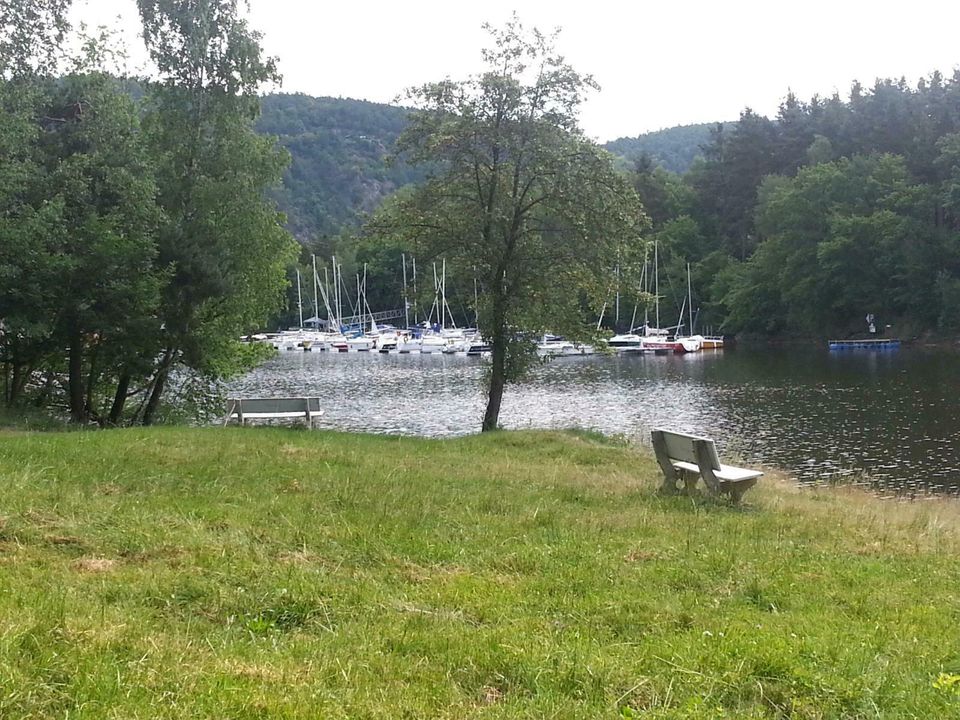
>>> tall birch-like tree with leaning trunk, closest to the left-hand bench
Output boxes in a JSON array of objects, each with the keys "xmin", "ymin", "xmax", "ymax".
[{"xmin": 132, "ymin": 0, "xmax": 296, "ymax": 424}]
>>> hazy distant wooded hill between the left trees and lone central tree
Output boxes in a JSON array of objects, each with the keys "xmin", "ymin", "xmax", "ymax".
[{"xmin": 257, "ymin": 94, "xmax": 421, "ymax": 244}]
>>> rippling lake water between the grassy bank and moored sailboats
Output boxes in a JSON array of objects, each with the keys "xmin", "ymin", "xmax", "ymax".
[{"xmin": 230, "ymin": 346, "xmax": 960, "ymax": 492}]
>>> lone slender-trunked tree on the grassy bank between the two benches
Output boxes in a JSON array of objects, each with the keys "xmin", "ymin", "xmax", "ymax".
[{"xmin": 370, "ymin": 18, "xmax": 644, "ymax": 431}]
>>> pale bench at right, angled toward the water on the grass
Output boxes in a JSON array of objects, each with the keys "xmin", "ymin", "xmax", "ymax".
[{"xmin": 650, "ymin": 429, "xmax": 763, "ymax": 502}]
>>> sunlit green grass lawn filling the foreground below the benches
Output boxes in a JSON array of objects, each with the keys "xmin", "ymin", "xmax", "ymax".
[{"xmin": 0, "ymin": 428, "xmax": 960, "ymax": 720}]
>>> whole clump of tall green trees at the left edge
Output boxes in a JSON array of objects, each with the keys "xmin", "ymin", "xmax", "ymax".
[{"xmin": 0, "ymin": 0, "xmax": 297, "ymax": 425}]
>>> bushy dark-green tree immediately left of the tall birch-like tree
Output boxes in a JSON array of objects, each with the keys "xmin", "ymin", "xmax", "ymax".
[{"xmin": 41, "ymin": 73, "xmax": 164, "ymax": 422}]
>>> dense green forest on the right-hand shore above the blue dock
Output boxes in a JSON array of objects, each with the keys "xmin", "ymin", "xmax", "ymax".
[{"xmin": 636, "ymin": 73, "xmax": 960, "ymax": 336}]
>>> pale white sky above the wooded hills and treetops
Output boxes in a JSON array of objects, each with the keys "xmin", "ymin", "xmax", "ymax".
[{"xmin": 65, "ymin": 0, "xmax": 960, "ymax": 142}]
